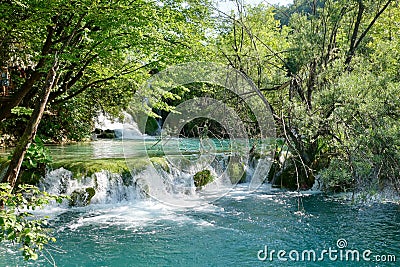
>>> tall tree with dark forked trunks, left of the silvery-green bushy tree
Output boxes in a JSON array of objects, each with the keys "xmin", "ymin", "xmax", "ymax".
[{"xmin": 278, "ymin": 1, "xmax": 392, "ymax": 191}]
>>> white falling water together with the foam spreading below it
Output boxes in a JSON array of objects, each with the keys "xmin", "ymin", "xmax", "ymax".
[{"xmin": 35, "ymin": 159, "xmax": 276, "ymax": 234}]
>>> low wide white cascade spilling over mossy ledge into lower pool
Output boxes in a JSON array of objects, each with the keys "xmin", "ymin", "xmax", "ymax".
[{"xmin": 39, "ymin": 156, "xmax": 253, "ymax": 206}]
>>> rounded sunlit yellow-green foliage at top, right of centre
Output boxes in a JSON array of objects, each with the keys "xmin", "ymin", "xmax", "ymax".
[{"xmin": 217, "ymin": 4, "xmax": 289, "ymax": 89}]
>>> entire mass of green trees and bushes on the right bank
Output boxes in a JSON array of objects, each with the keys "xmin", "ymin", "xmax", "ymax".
[{"xmin": 218, "ymin": 0, "xmax": 400, "ymax": 194}]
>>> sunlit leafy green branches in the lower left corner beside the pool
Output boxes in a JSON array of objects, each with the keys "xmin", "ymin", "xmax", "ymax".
[{"xmin": 0, "ymin": 184, "xmax": 63, "ymax": 260}]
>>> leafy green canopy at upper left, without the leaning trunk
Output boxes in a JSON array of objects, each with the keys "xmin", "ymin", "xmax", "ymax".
[{"xmin": 0, "ymin": 0, "xmax": 216, "ymax": 142}]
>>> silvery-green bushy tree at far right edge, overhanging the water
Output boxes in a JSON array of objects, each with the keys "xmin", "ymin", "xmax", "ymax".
[{"xmin": 323, "ymin": 5, "xmax": 400, "ymax": 193}]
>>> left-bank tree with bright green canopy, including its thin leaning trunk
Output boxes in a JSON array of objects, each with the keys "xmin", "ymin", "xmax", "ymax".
[{"xmin": 0, "ymin": 0, "xmax": 214, "ymax": 189}]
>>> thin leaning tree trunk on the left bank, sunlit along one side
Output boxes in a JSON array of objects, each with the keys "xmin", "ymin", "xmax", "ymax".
[{"xmin": 3, "ymin": 59, "xmax": 58, "ymax": 191}]
